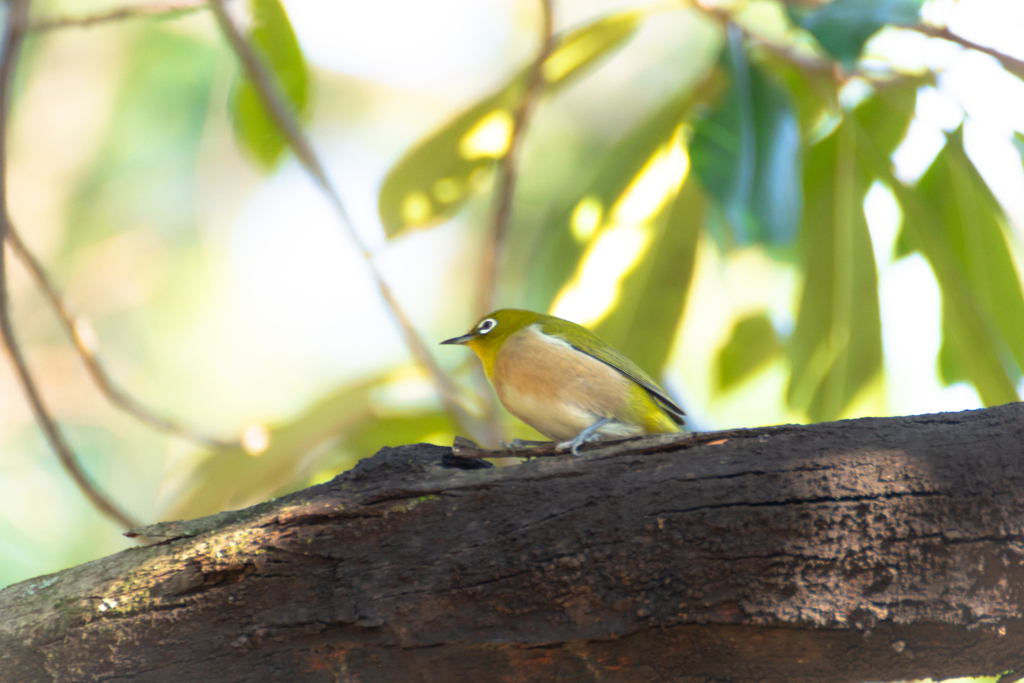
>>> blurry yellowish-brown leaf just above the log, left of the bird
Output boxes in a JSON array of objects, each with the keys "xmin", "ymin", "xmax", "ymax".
[{"xmin": 164, "ymin": 376, "xmax": 386, "ymax": 519}]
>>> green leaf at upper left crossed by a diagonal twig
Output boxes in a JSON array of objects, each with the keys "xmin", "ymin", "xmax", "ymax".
[{"xmin": 231, "ymin": 0, "xmax": 309, "ymax": 169}]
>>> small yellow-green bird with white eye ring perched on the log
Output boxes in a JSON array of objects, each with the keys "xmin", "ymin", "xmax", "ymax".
[{"xmin": 441, "ymin": 308, "xmax": 685, "ymax": 455}]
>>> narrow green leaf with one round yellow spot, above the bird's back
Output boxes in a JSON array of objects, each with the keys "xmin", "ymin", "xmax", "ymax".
[{"xmin": 526, "ymin": 88, "xmax": 705, "ymax": 310}]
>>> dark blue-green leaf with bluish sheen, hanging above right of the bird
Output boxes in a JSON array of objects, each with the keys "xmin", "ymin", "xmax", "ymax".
[{"xmin": 690, "ymin": 26, "xmax": 803, "ymax": 245}]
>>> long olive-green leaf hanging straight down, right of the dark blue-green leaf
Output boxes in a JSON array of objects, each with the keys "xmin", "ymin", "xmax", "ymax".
[{"xmin": 786, "ymin": 123, "xmax": 882, "ymax": 422}]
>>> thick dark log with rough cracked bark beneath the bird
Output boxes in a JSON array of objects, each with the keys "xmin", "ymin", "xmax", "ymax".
[{"xmin": 0, "ymin": 403, "xmax": 1024, "ymax": 683}]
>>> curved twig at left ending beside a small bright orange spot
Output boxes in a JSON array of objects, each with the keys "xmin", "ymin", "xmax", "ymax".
[{"xmin": 7, "ymin": 223, "xmax": 238, "ymax": 449}]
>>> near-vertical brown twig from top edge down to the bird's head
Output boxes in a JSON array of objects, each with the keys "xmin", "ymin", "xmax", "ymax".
[{"xmin": 476, "ymin": 0, "xmax": 555, "ymax": 317}]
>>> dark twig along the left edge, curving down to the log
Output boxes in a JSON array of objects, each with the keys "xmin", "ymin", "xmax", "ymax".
[{"xmin": 0, "ymin": 0, "xmax": 138, "ymax": 529}]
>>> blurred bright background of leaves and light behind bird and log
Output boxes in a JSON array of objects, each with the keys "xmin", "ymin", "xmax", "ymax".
[{"xmin": 0, "ymin": 0, "xmax": 1024, "ymax": 587}]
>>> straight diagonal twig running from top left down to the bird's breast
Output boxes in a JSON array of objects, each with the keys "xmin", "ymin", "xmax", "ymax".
[{"xmin": 209, "ymin": 0, "xmax": 480, "ymax": 444}]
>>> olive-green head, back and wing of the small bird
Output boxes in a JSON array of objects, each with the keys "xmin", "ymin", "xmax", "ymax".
[{"xmin": 474, "ymin": 308, "xmax": 685, "ymax": 424}]
